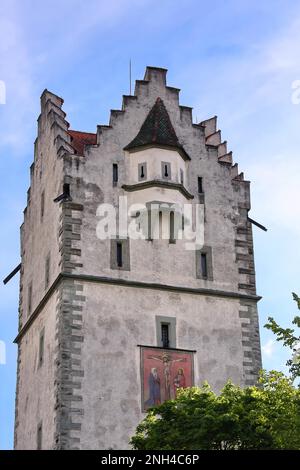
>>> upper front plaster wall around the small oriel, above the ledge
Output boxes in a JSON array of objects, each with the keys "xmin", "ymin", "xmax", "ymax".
[{"xmin": 65, "ymin": 72, "xmax": 244, "ymax": 292}]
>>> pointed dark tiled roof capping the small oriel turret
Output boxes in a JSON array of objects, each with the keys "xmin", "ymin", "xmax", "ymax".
[{"xmin": 124, "ymin": 97, "xmax": 190, "ymax": 160}]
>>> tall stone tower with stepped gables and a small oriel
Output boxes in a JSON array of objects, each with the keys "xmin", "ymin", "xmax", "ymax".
[{"xmin": 15, "ymin": 67, "xmax": 261, "ymax": 449}]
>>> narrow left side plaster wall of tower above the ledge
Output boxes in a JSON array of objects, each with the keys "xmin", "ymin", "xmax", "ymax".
[{"xmin": 21, "ymin": 100, "xmax": 63, "ymax": 324}]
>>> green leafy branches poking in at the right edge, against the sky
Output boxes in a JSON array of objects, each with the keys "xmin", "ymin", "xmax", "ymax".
[{"xmin": 265, "ymin": 292, "xmax": 300, "ymax": 379}]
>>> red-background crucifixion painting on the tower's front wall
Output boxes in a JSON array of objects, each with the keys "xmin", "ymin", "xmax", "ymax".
[{"xmin": 141, "ymin": 347, "xmax": 194, "ymax": 410}]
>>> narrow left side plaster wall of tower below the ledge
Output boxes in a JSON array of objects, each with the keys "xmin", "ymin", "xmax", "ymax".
[{"xmin": 16, "ymin": 294, "xmax": 57, "ymax": 450}]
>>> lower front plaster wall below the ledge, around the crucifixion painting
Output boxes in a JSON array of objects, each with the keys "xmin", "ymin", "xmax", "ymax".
[{"xmin": 80, "ymin": 283, "xmax": 243, "ymax": 449}]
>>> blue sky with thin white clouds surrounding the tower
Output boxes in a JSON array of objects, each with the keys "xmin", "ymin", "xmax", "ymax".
[{"xmin": 0, "ymin": 0, "xmax": 300, "ymax": 449}]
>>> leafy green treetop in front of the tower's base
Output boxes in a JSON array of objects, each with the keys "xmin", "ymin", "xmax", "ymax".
[{"xmin": 130, "ymin": 371, "xmax": 300, "ymax": 450}]
